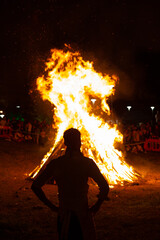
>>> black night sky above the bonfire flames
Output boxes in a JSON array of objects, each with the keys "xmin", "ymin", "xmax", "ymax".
[{"xmin": 0, "ymin": 0, "xmax": 160, "ymax": 110}]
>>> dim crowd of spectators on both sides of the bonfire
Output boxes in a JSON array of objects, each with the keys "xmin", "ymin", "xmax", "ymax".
[{"xmin": 0, "ymin": 113, "xmax": 160, "ymax": 152}]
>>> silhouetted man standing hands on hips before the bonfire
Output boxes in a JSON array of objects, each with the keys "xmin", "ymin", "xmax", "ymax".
[{"xmin": 32, "ymin": 128, "xmax": 109, "ymax": 240}]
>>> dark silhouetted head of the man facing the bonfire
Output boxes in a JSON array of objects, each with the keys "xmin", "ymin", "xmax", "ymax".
[{"xmin": 63, "ymin": 128, "xmax": 81, "ymax": 150}]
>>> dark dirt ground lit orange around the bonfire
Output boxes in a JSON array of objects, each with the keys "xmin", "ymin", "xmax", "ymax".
[{"xmin": 0, "ymin": 140, "xmax": 160, "ymax": 240}]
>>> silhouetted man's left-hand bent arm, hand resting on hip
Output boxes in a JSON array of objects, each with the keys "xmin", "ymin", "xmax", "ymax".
[{"xmin": 31, "ymin": 163, "xmax": 58, "ymax": 212}]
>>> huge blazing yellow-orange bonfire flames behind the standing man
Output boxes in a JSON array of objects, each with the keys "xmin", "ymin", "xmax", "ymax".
[{"xmin": 30, "ymin": 46, "xmax": 137, "ymax": 184}]
